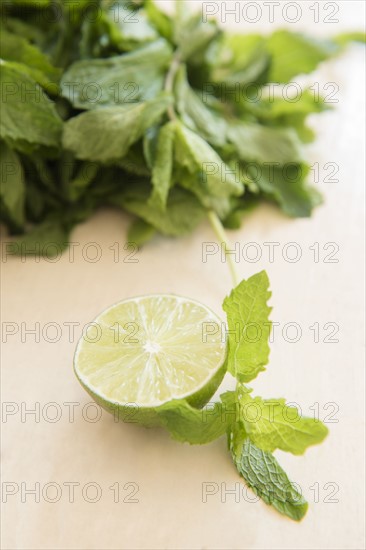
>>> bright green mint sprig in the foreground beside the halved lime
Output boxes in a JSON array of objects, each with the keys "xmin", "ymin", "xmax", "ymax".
[{"xmin": 158, "ymin": 271, "xmax": 328, "ymax": 521}]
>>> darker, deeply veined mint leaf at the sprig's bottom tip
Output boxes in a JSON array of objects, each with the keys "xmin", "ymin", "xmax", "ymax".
[{"xmin": 233, "ymin": 438, "xmax": 308, "ymax": 521}]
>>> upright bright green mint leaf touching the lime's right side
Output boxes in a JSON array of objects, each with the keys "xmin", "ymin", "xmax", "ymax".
[{"xmin": 223, "ymin": 271, "xmax": 271, "ymax": 382}]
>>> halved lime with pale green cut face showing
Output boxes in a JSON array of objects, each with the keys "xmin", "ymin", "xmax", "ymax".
[{"xmin": 74, "ymin": 295, "xmax": 227, "ymax": 422}]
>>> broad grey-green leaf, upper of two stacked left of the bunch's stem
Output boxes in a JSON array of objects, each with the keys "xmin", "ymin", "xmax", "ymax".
[{"xmin": 61, "ymin": 39, "xmax": 172, "ymax": 109}]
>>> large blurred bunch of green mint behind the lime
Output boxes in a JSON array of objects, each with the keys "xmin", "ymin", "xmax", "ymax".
[{"xmin": 0, "ymin": 0, "xmax": 363, "ymax": 253}]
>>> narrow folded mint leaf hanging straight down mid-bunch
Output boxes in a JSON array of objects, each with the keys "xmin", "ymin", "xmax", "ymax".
[{"xmin": 150, "ymin": 121, "xmax": 176, "ymax": 210}]
